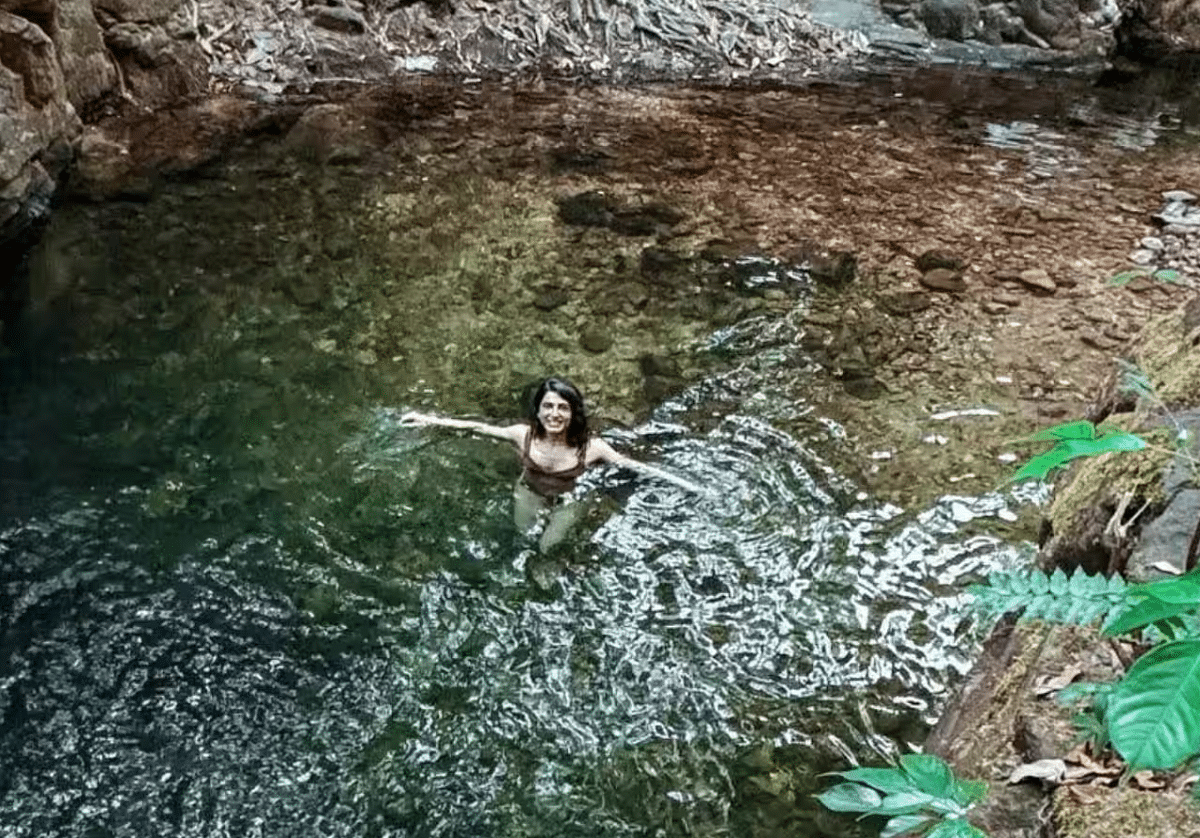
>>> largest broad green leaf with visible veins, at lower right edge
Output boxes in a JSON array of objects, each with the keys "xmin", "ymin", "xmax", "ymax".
[{"xmin": 1105, "ymin": 639, "xmax": 1200, "ymax": 771}]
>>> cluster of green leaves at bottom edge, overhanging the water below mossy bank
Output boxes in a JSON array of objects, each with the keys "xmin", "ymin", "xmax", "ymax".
[{"xmin": 817, "ymin": 754, "xmax": 988, "ymax": 838}]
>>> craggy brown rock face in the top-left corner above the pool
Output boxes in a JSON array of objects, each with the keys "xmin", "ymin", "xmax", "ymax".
[{"xmin": 0, "ymin": 0, "xmax": 208, "ymax": 333}]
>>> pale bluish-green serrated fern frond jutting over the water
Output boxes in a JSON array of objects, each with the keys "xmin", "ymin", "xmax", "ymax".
[{"xmin": 970, "ymin": 569, "xmax": 1126, "ymax": 625}]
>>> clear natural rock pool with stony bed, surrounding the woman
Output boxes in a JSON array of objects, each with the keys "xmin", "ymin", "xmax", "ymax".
[{"xmin": 0, "ymin": 66, "xmax": 1189, "ymax": 838}]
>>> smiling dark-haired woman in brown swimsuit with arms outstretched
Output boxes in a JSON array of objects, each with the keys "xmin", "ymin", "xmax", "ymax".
[{"xmin": 401, "ymin": 378, "xmax": 701, "ymax": 551}]
